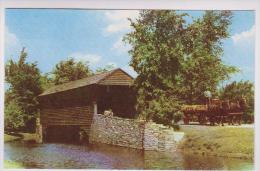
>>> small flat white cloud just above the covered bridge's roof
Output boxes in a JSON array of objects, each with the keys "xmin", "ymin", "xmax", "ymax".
[{"xmin": 69, "ymin": 52, "xmax": 101, "ymax": 65}]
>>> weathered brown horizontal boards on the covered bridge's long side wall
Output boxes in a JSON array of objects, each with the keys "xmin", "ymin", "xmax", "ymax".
[{"xmin": 40, "ymin": 106, "xmax": 93, "ymax": 132}]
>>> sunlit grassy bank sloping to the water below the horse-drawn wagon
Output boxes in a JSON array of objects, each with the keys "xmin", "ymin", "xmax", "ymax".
[{"xmin": 179, "ymin": 125, "xmax": 254, "ymax": 158}]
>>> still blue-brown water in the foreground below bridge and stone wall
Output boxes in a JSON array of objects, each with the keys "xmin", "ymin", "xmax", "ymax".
[{"xmin": 4, "ymin": 141, "xmax": 253, "ymax": 170}]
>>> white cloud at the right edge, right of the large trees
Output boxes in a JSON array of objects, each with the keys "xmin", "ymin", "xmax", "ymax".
[{"xmin": 231, "ymin": 25, "xmax": 255, "ymax": 44}]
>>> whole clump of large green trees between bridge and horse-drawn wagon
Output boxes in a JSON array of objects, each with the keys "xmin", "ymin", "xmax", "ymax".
[{"xmin": 124, "ymin": 10, "xmax": 236, "ymax": 124}]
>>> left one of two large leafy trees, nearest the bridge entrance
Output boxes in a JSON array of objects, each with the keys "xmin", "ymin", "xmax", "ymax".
[{"xmin": 124, "ymin": 10, "xmax": 186, "ymax": 119}]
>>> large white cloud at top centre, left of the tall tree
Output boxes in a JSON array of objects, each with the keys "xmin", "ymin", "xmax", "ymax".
[{"xmin": 105, "ymin": 10, "xmax": 139, "ymax": 33}]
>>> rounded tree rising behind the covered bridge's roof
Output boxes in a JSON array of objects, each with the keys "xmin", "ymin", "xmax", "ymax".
[{"xmin": 52, "ymin": 58, "xmax": 92, "ymax": 85}]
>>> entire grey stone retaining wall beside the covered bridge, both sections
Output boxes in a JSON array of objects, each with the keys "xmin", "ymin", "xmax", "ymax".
[{"xmin": 89, "ymin": 114, "xmax": 183, "ymax": 151}]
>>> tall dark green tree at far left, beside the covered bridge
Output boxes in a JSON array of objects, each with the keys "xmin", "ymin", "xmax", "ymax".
[{"xmin": 5, "ymin": 48, "xmax": 42, "ymax": 131}]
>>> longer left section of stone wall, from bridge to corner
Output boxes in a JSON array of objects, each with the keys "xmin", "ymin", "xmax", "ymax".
[{"xmin": 89, "ymin": 114, "xmax": 144, "ymax": 149}]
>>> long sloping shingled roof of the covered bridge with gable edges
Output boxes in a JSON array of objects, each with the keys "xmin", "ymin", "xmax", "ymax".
[{"xmin": 39, "ymin": 68, "xmax": 133, "ymax": 96}]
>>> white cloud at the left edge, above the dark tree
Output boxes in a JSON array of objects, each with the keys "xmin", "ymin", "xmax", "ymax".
[{"xmin": 4, "ymin": 26, "xmax": 22, "ymax": 58}]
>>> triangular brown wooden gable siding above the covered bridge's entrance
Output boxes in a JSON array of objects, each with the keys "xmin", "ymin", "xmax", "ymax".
[{"xmin": 99, "ymin": 70, "xmax": 133, "ymax": 85}]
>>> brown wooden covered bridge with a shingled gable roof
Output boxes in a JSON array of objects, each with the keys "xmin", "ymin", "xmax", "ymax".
[{"xmin": 39, "ymin": 68, "xmax": 136, "ymax": 142}]
